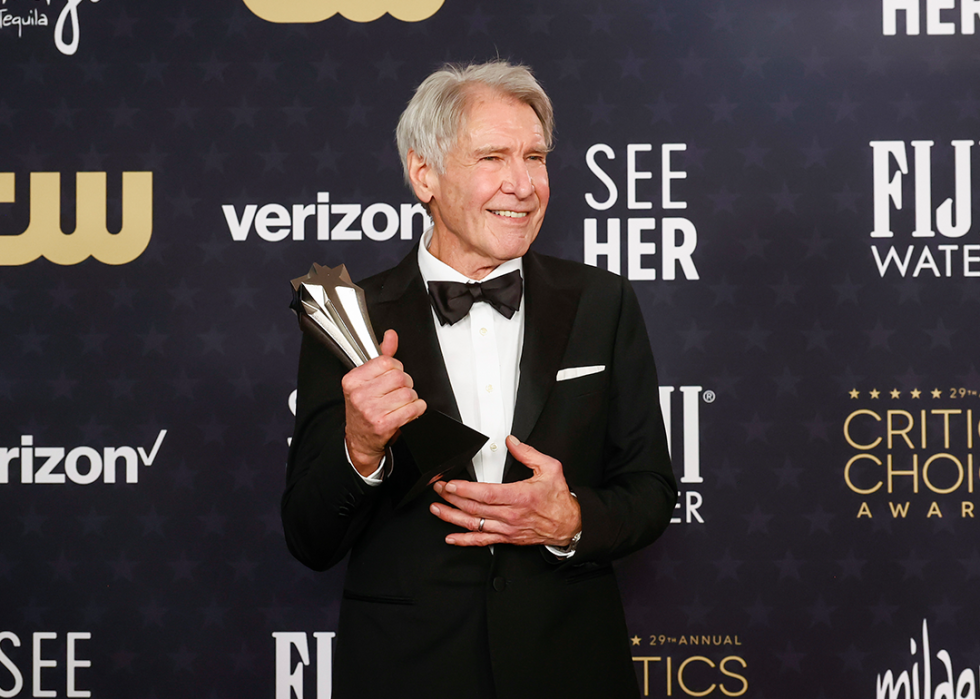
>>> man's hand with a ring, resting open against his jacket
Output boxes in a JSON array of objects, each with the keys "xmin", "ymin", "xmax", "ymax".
[{"xmin": 430, "ymin": 436, "xmax": 582, "ymax": 546}]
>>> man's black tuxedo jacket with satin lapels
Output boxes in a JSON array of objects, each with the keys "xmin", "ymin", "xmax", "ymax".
[{"xmin": 282, "ymin": 250, "xmax": 676, "ymax": 699}]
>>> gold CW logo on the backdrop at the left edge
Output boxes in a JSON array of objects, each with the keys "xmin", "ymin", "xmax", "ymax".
[{"xmin": 0, "ymin": 172, "xmax": 153, "ymax": 266}]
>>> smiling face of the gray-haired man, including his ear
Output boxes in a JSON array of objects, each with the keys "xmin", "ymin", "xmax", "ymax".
[{"xmin": 408, "ymin": 87, "xmax": 550, "ymax": 279}]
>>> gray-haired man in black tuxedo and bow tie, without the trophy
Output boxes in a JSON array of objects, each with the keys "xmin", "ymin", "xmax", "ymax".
[{"xmin": 282, "ymin": 62, "xmax": 676, "ymax": 699}]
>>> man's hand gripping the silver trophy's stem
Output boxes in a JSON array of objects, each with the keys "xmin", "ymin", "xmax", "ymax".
[{"xmin": 341, "ymin": 330, "xmax": 425, "ymax": 476}]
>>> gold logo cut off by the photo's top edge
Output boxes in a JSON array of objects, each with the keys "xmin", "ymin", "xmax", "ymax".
[{"xmin": 245, "ymin": 0, "xmax": 445, "ymax": 23}]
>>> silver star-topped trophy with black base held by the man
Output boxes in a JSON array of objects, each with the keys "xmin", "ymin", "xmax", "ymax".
[{"xmin": 289, "ymin": 263, "xmax": 487, "ymax": 507}]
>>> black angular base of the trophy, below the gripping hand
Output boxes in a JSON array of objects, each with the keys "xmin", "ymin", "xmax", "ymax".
[{"xmin": 392, "ymin": 410, "xmax": 488, "ymax": 507}]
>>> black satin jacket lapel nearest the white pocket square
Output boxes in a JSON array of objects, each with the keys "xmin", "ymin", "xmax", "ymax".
[{"xmin": 504, "ymin": 253, "xmax": 580, "ymax": 481}]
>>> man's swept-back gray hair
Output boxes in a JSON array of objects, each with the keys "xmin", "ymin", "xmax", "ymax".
[{"xmin": 395, "ymin": 61, "xmax": 555, "ymax": 186}]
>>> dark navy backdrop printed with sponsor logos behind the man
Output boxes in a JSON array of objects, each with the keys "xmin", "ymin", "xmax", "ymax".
[{"xmin": 0, "ymin": 0, "xmax": 980, "ymax": 699}]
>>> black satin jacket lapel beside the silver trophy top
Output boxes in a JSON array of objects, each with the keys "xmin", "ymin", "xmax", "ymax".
[{"xmin": 368, "ymin": 246, "xmax": 459, "ymax": 420}]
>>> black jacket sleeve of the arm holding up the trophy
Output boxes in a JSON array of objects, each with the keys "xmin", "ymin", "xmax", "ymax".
[{"xmin": 282, "ymin": 335, "xmax": 381, "ymax": 570}]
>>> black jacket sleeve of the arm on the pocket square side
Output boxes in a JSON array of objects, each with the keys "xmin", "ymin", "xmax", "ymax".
[{"xmin": 569, "ymin": 279, "xmax": 677, "ymax": 565}]
